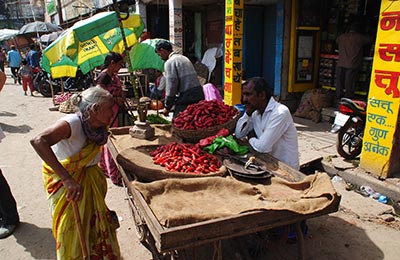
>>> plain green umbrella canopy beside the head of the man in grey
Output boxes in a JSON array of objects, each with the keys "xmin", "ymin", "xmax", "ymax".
[{"xmin": 129, "ymin": 39, "xmax": 164, "ymax": 71}]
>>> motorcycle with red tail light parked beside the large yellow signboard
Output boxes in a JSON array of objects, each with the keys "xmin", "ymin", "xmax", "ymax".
[{"xmin": 331, "ymin": 98, "xmax": 367, "ymax": 160}]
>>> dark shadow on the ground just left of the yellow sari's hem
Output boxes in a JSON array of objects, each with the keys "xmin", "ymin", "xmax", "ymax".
[{"xmin": 13, "ymin": 222, "xmax": 57, "ymax": 259}]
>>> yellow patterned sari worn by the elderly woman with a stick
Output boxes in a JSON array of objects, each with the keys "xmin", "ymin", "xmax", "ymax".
[{"xmin": 43, "ymin": 143, "xmax": 120, "ymax": 260}]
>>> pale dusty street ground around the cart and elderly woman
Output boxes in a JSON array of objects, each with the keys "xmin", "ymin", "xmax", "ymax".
[{"xmin": 0, "ymin": 70, "xmax": 400, "ymax": 260}]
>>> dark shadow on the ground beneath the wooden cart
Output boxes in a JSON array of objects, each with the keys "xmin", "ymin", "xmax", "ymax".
[{"xmin": 178, "ymin": 215, "xmax": 384, "ymax": 260}]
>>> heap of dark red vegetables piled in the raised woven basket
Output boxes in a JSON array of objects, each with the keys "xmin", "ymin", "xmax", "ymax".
[{"xmin": 172, "ymin": 100, "xmax": 238, "ymax": 130}]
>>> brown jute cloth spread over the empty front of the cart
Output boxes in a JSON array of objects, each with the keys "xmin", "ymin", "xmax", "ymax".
[{"xmin": 131, "ymin": 173, "xmax": 338, "ymax": 227}]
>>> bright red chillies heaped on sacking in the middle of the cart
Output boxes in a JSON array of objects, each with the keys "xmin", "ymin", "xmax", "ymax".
[{"xmin": 150, "ymin": 142, "xmax": 221, "ymax": 174}]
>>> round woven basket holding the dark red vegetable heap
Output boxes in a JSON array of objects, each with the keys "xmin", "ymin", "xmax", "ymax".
[{"xmin": 172, "ymin": 111, "xmax": 240, "ymax": 143}]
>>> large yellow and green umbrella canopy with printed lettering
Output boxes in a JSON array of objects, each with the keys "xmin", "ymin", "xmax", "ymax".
[{"xmin": 41, "ymin": 11, "xmax": 144, "ymax": 78}]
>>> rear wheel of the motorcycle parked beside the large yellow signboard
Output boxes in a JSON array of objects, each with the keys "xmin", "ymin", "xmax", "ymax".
[{"xmin": 336, "ymin": 120, "xmax": 364, "ymax": 160}]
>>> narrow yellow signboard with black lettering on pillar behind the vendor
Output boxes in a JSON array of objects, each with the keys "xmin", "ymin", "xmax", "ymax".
[{"xmin": 224, "ymin": 0, "xmax": 244, "ymax": 105}]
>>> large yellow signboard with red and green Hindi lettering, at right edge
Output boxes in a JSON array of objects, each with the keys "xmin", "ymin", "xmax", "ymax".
[{"xmin": 361, "ymin": 0, "xmax": 400, "ymax": 178}]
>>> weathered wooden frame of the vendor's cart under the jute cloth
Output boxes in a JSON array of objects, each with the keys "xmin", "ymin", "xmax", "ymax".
[{"xmin": 108, "ymin": 126, "xmax": 340, "ymax": 259}]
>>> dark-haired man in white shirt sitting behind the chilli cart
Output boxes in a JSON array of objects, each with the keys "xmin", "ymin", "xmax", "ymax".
[{"xmin": 235, "ymin": 77, "xmax": 299, "ymax": 170}]
